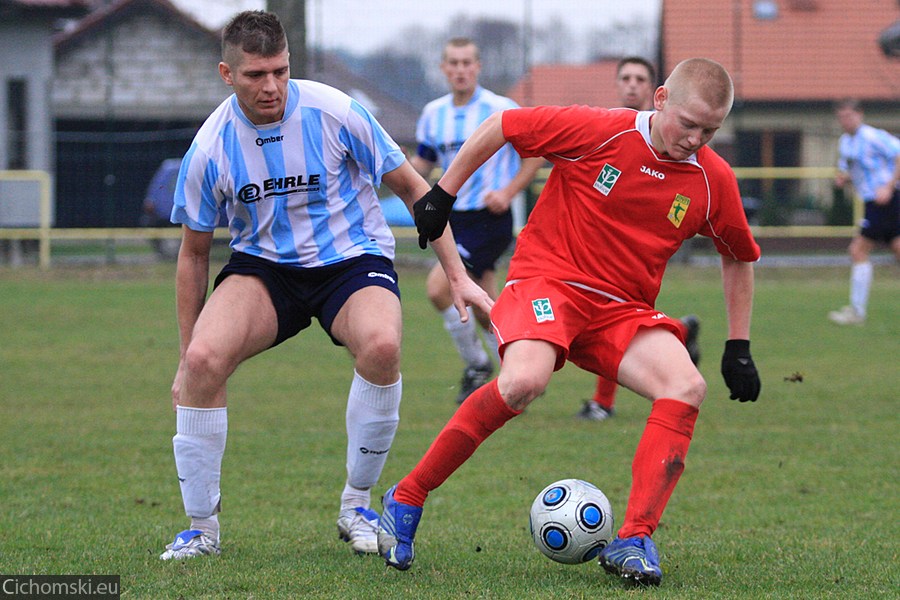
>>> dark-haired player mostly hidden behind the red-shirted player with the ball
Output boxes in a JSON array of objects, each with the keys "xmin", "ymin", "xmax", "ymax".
[{"xmin": 580, "ymin": 56, "xmax": 700, "ymax": 421}]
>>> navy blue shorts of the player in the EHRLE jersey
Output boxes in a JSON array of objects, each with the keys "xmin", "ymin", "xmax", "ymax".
[{"xmin": 213, "ymin": 252, "xmax": 400, "ymax": 347}]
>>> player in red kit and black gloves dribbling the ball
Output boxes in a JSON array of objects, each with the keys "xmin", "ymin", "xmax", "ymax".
[{"xmin": 378, "ymin": 58, "xmax": 760, "ymax": 585}]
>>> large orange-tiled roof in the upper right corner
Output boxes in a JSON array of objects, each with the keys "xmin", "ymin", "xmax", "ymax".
[{"xmin": 662, "ymin": 0, "xmax": 900, "ymax": 102}]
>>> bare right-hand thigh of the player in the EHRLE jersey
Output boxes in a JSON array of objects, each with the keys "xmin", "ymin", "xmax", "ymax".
[{"xmin": 331, "ymin": 285, "xmax": 403, "ymax": 360}]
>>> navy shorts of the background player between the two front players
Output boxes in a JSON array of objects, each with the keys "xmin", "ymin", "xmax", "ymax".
[{"xmin": 450, "ymin": 209, "xmax": 512, "ymax": 277}]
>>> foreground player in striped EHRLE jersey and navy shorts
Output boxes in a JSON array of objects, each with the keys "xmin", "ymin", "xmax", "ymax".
[{"xmin": 160, "ymin": 11, "xmax": 492, "ymax": 560}]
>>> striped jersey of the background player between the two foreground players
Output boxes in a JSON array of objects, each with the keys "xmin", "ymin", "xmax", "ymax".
[{"xmin": 416, "ymin": 86, "xmax": 521, "ymax": 211}]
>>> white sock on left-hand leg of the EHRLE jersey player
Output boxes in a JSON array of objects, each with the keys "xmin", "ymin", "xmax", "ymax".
[{"xmin": 172, "ymin": 406, "xmax": 228, "ymax": 539}]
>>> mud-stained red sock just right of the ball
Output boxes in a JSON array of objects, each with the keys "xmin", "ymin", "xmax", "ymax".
[{"xmin": 619, "ymin": 398, "xmax": 699, "ymax": 538}]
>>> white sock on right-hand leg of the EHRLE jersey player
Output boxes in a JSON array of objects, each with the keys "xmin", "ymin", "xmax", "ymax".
[{"xmin": 342, "ymin": 370, "xmax": 403, "ymax": 494}]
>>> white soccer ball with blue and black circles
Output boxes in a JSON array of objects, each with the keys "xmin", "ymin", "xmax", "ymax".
[{"xmin": 530, "ymin": 479, "xmax": 615, "ymax": 565}]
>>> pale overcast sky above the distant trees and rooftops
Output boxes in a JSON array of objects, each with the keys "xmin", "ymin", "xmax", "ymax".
[{"xmin": 173, "ymin": 0, "xmax": 661, "ymax": 52}]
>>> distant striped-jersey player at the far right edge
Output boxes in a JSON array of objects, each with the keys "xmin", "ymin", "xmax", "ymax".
[{"xmin": 828, "ymin": 98, "xmax": 900, "ymax": 325}]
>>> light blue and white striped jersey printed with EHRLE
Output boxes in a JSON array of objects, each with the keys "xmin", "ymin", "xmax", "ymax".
[{"xmin": 171, "ymin": 79, "xmax": 406, "ymax": 267}]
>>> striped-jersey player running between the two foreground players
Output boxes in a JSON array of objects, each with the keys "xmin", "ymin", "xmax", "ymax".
[{"xmin": 410, "ymin": 37, "xmax": 544, "ymax": 402}]
